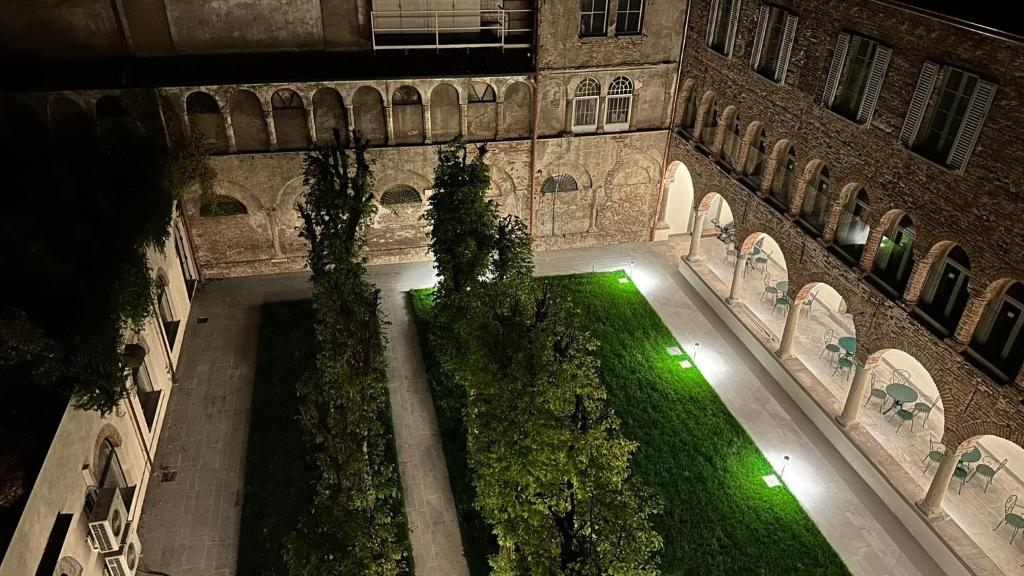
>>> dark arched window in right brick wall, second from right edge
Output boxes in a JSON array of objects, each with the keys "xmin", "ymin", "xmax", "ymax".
[{"xmin": 914, "ymin": 244, "xmax": 971, "ymax": 337}]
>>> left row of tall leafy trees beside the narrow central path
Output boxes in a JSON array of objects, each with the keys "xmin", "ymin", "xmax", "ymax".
[{"xmin": 286, "ymin": 131, "xmax": 412, "ymax": 576}]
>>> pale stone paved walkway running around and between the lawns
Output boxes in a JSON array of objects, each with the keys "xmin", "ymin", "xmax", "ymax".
[{"xmin": 136, "ymin": 240, "xmax": 942, "ymax": 576}]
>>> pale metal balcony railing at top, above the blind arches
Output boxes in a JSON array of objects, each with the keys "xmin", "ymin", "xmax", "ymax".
[{"xmin": 370, "ymin": 9, "xmax": 534, "ymax": 50}]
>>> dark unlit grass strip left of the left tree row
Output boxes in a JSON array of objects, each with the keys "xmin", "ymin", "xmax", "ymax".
[{"xmin": 238, "ymin": 300, "xmax": 316, "ymax": 576}]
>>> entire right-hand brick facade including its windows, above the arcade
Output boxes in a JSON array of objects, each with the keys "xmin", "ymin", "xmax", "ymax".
[{"xmin": 665, "ymin": 0, "xmax": 1024, "ymax": 511}]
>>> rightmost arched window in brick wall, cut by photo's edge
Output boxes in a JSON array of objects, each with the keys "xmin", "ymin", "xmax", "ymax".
[{"xmin": 968, "ymin": 282, "xmax": 1024, "ymax": 382}]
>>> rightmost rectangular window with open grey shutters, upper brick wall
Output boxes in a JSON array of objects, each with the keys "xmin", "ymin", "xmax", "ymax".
[{"xmin": 899, "ymin": 61, "xmax": 996, "ymax": 171}]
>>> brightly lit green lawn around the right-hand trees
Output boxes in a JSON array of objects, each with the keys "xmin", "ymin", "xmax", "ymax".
[{"xmin": 414, "ymin": 273, "xmax": 848, "ymax": 576}]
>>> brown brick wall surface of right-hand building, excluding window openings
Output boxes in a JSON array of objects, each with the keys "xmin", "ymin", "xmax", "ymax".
[{"xmin": 669, "ymin": 0, "xmax": 1024, "ymax": 446}]
